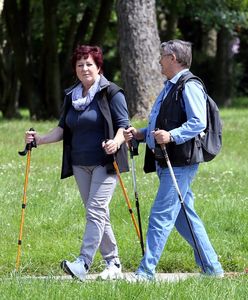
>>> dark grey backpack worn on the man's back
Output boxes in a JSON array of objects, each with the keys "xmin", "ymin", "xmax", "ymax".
[{"xmin": 176, "ymin": 72, "xmax": 222, "ymax": 162}]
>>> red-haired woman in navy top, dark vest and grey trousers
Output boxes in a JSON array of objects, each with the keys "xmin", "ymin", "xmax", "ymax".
[{"xmin": 26, "ymin": 45, "xmax": 129, "ymax": 281}]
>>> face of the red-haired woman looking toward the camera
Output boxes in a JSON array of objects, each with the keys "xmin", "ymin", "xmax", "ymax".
[{"xmin": 76, "ymin": 55, "xmax": 100, "ymax": 88}]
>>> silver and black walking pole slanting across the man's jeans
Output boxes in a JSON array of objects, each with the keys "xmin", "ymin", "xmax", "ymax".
[{"xmin": 155, "ymin": 128, "xmax": 206, "ymax": 273}]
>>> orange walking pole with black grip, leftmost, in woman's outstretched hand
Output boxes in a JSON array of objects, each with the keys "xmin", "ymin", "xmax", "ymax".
[{"xmin": 16, "ymin": 128, "xmax": 36, "ymax": 271}]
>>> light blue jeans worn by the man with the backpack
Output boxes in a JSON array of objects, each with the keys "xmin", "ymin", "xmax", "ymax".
[{"xmin": 137, "ymin": 164, "xmax": 223, "ymax": 277}]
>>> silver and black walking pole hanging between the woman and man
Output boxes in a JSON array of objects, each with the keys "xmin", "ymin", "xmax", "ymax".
[{"xmin": 128, "ymin": 129, "xmax": 145, "ymax": 256}]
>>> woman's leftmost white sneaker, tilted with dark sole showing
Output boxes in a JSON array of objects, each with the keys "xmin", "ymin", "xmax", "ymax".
[{"xmin": 61, "ymin": 258, "xmax": 87, "ymax": 281}]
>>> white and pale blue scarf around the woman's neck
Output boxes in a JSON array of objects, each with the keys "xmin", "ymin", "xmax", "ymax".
[{"xmin": 72, "ymin": 75, "xmax": 100, "ymax": 110}]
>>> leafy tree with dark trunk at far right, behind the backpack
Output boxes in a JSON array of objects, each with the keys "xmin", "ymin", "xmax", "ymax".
[{"xmin": 184, "ymin": 0, "xmax": 248, "ymax": 106}]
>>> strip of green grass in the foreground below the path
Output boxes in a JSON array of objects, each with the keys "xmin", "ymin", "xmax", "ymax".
[{"xmin": 0, "ymin": 276, "xmax": 247, "ymax": 300}]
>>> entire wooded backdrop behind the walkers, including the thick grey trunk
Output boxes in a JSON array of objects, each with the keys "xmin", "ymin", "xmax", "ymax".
[{"xmin": 0, "ymin": 0, "xmax": 248, "ymax": 119}]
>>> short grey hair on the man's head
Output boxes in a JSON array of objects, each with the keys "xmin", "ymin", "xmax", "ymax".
[{"xmin": 160, "ymin": 40, "xmax": 192, "ymax": 68}]
